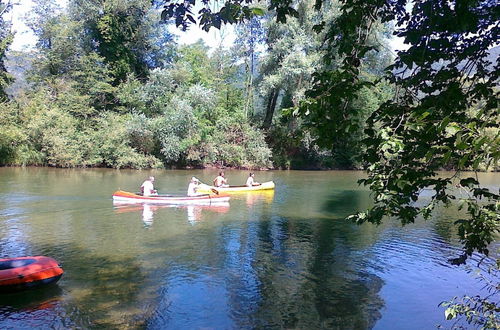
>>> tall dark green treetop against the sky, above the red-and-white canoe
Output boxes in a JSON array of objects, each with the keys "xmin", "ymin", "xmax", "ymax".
[{"xmin": 69, "ymin": 0, "xmax": 174, "ymax": 86}]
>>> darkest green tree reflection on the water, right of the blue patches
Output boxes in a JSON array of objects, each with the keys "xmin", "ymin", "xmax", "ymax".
[{"xmin": 309, "ymin": 219, "xmax": 383, "ymax": 329}]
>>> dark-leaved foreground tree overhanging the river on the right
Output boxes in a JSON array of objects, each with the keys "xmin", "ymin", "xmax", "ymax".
[{"xmin": 296, "ymin": 1, "xmax": 500, "ymax": 326}]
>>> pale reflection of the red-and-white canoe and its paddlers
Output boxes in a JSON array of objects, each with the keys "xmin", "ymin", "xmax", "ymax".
[{"xmin": 113, "ymin": 201, "xmax": 230, "ymax": 228}]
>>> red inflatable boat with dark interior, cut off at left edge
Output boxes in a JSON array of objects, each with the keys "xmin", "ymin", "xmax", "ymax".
[{"xmin": 0, "ymin": 256, "xmax": 64, "ymax": 292}]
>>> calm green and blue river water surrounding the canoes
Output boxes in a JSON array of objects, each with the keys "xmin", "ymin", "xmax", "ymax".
[{"xmin": 0, "ymin": 168, "xmax": 500, "ymax": 329}]
